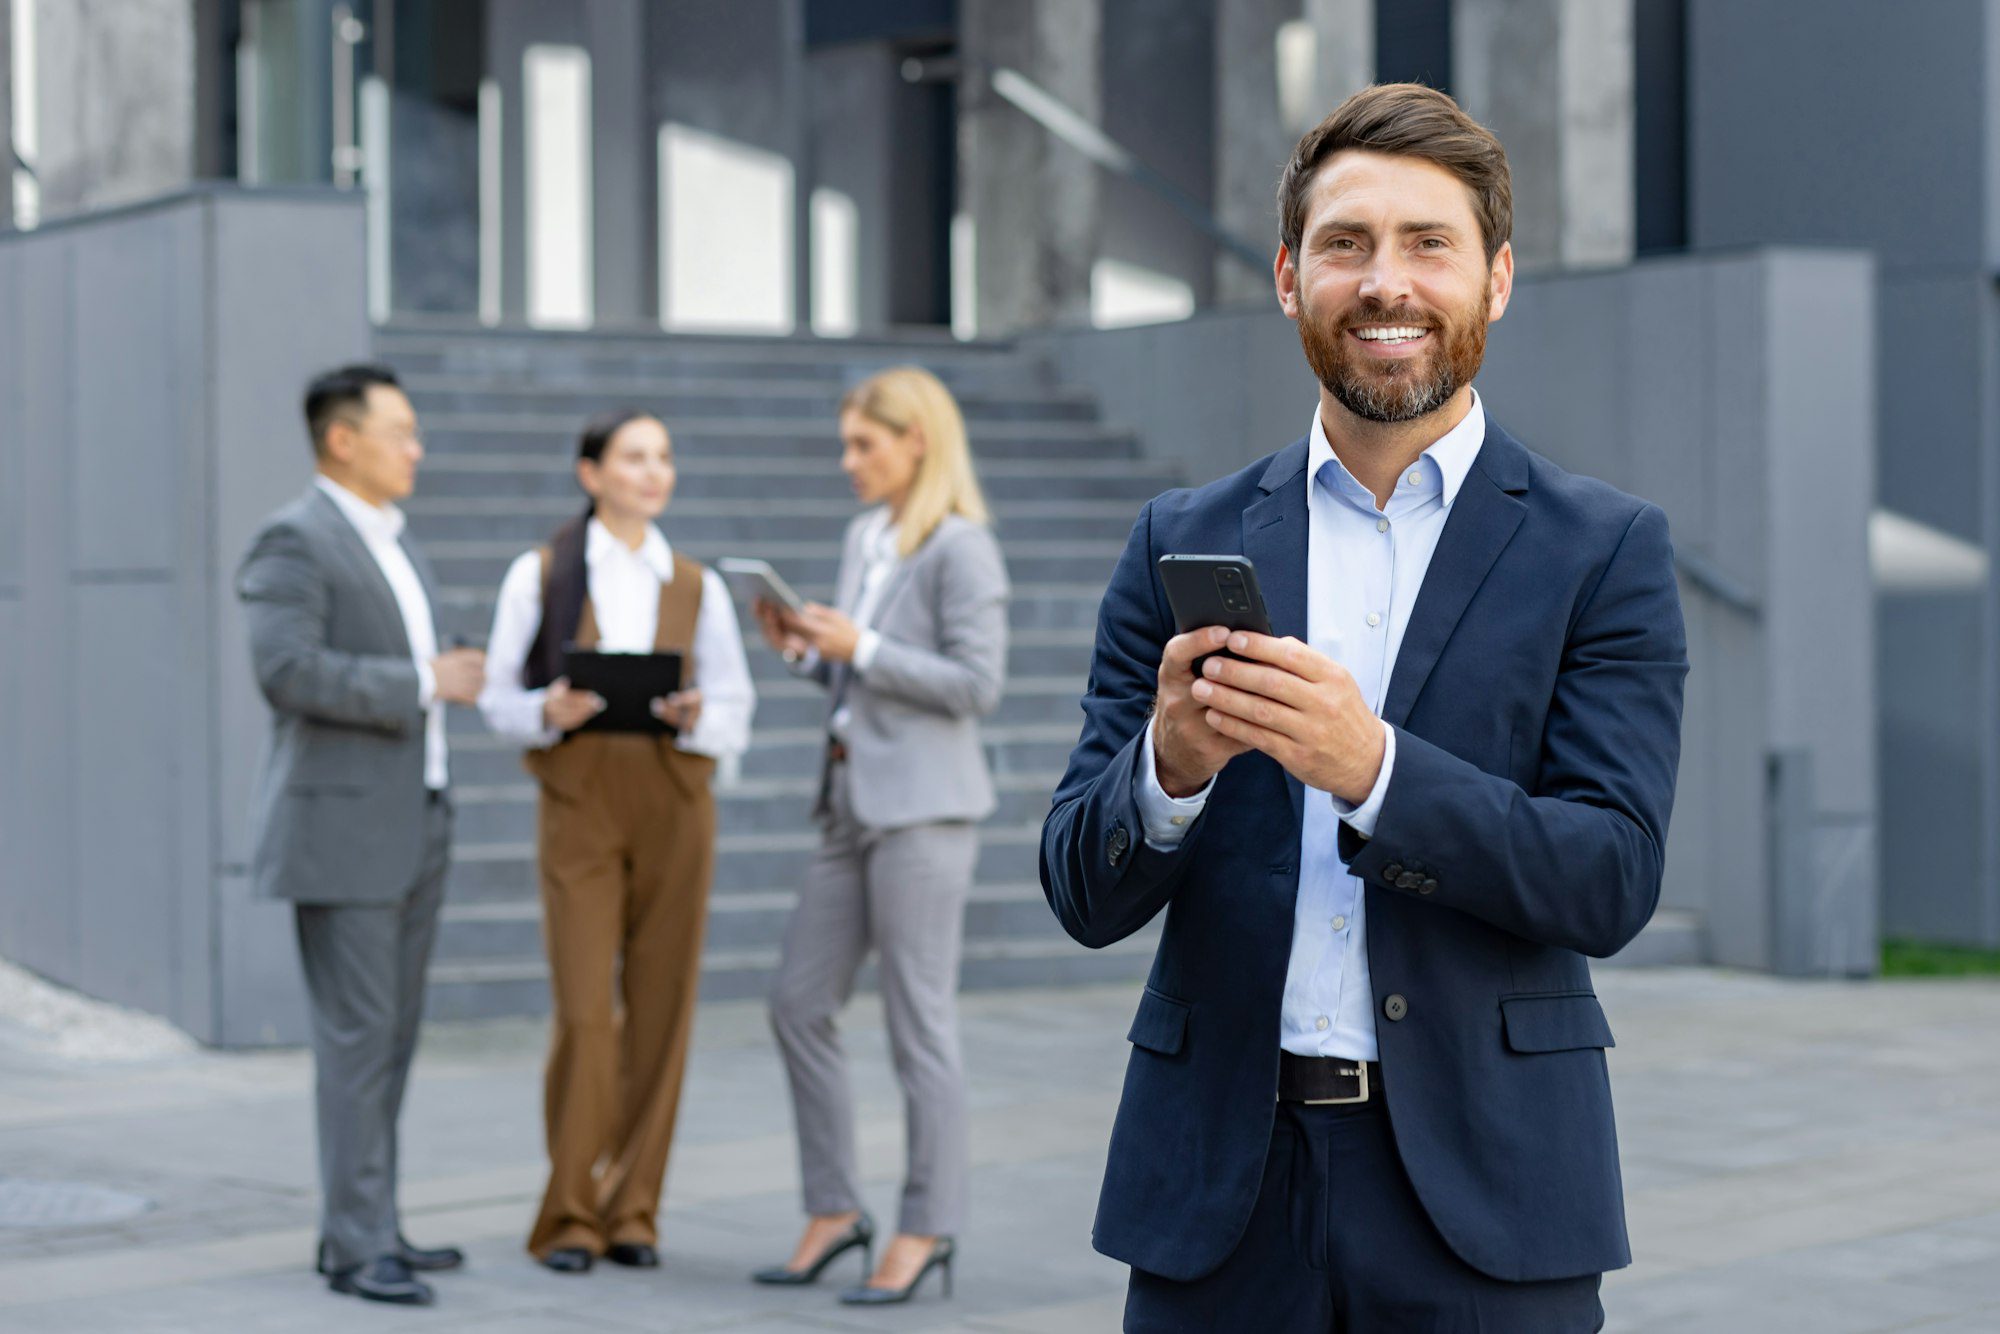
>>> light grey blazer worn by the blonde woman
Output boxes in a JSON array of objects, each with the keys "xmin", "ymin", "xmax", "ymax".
[{"xmin": 812, "ymin": 514, "xmax": 1008, "ymax": 830}]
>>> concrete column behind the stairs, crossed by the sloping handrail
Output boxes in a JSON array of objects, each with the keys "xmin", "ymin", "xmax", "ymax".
[{"xmin": 954, "ymin": 0, "xmax": 1104, "ymax": 334}]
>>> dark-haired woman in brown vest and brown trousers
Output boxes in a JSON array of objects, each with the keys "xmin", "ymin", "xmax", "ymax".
[{"xmin": 480, "ymin": 412, "xmax": 756, "ymax": 1274}]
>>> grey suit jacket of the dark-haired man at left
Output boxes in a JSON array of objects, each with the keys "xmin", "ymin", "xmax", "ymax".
[{"xmin": 236, "ymin": 486, "xmax": 436, "ymax": 904}]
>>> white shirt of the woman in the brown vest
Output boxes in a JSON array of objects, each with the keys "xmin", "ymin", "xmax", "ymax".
[{"xmin": 480, "ymin": 518, "xmax": 756, "ymax": 760}]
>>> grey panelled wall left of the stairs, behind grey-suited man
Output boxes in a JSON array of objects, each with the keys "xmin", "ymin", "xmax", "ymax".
[{"xmin": 0, "ymin": 192, "xmax": 368, "ymax": 1042}]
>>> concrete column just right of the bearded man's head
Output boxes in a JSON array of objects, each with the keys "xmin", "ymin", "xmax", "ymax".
[{"xmin": 1452, "ymin": 0, "xmax": 1634, "ymax": 268}]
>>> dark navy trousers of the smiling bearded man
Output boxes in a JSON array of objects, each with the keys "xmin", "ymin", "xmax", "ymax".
[{"xmin": 1124, "ymin": 1100, "xmax": 1604, "ymax": 1334}]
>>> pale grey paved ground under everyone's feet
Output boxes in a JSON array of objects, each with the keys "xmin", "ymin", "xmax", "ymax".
[{"xmin": 0, "ymin": 970, "xmax": 2000, "ymax": 1334}]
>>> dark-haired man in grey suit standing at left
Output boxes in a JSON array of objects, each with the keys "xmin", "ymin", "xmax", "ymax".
[{"xmin": 236, "ymin": 366, "xmax": 486, "ymax": 1304}]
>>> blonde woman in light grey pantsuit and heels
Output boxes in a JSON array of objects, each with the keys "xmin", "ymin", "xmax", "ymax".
[{"xmin": 756, "ymin": 366, "xmax": 1008, "ymax": 1306}]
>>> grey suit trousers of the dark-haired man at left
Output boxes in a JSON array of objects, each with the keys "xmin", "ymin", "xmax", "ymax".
[{"xmin": 296, "ymin": 798, "xmax": 452, "ymax": 1270}]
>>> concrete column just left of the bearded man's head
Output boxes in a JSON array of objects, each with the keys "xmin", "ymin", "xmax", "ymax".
[{"xmin": 1216, "ymin": 0, "xmax": 1374, "ymax": 302}]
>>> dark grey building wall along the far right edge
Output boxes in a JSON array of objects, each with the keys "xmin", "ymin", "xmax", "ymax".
[{"xmin": 1688, "ymin": 0, "xmax": 2000, "ymax": 946}]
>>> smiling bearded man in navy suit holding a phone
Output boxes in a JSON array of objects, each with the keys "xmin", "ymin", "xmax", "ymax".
[{"xmin": 1042, "ymin": 84, "xmax": 1688, "ymax": 1334}]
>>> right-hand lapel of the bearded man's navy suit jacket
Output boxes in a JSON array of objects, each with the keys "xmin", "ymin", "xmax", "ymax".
[{"xmin": 1382, "ymin": 422, "xmax": 1528, "ymax": 728}]
